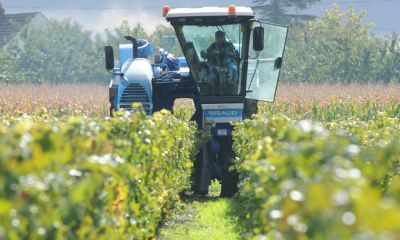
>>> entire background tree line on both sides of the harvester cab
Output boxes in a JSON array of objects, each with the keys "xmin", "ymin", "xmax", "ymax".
[{"xmin": 0, "ymin": 0, "xmax": 400, "ymax": 84}]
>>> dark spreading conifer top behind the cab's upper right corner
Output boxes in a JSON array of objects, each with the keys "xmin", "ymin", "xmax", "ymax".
[{"xmin": 253, "ymin": 0, "xmax": 321, "ymax": 24}]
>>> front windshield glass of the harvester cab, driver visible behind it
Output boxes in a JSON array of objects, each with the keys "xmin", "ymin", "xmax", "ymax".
[{"xmin": 177, "ymin": 24, "xmax": 246, "ymax": 96}]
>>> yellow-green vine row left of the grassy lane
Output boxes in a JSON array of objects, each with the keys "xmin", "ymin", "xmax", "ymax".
[{"xmin": 0, "ymin": 111, "xmax": 195, "ymax": 239}]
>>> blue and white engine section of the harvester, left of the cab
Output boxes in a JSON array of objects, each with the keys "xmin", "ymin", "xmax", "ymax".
[{"xmin": 109, "ymin": 36, "xmax": 201, "ymax": 115}]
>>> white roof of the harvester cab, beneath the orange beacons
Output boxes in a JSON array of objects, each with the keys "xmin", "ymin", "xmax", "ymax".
[{"xmin": 165, "ymin": 7, "xmax": 254, "ymax": 18}]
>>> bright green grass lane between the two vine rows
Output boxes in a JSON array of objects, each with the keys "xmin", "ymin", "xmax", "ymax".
[{"xmin": 158, "ymin": 183, "xmax": 243, "ymax": 240}]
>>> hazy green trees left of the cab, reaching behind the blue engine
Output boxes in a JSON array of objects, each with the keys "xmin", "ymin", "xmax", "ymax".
[{"xmin": 0, "ymin": 19, "xmax": 182, "ymax": 84}]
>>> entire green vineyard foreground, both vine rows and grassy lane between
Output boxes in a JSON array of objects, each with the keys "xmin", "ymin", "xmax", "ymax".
[{"xmin": 0, "ymin": 87, "xmax": 400, "ymax": 240}]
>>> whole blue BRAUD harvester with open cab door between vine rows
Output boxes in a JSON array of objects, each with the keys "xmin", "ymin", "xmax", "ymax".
[{"xmin": 106, "ymin": 5, "xmax": 288, "ymax": 196}]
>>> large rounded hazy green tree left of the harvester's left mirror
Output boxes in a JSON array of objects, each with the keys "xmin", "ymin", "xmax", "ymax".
[{"xmin": 0, "ymin": 20, "xmax": 106, "ymax": 84}]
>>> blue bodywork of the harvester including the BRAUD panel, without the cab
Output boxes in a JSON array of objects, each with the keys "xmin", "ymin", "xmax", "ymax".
[{"xmin": 109, "ymin": 36, "xmax": 244, "ymax": 186}]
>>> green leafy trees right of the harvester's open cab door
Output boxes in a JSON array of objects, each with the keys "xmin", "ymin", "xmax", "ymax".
[{"xmin": 282, "ymin": 5, "xmax": 400, "ymax": 84}]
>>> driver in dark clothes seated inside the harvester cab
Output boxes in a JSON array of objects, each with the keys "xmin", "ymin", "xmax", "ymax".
[{"xmin": 201, "ymin": 31, "xmax": 239, "ymax": 95}]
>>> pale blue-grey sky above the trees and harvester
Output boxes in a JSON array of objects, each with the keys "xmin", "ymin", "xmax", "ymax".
[{"xmin": 0, "ymin": 0, "xmax": 400, "ymax": 35}]
